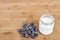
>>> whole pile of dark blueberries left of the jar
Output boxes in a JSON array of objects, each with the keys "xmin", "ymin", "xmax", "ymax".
[{"xmin": 18, "ymin": 22, "xmax": 38, "ymax": 39}]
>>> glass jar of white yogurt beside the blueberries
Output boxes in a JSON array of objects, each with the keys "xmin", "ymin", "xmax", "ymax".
[{"xmin": 39, "ymin": 14, "xmax": 54, "ymax": 35}]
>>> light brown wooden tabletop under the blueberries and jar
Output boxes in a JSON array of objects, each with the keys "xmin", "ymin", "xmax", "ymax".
[{"xmin": 0, "ymin": 0, "xmax": 60, "ymax": 40}]
